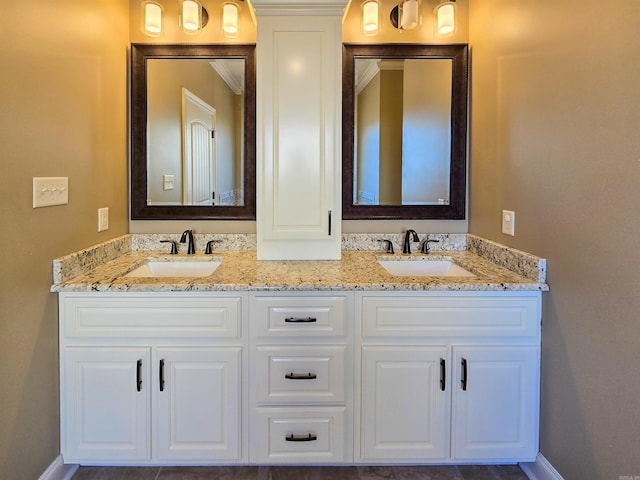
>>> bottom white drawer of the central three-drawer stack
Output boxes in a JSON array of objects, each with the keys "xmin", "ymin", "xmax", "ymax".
[{"xmin": 254, "ymin": 407, "xmax": 346, "ymax": 463}]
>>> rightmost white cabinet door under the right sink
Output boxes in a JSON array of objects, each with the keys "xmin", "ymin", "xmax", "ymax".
[{"xmin": 452, "ymin": 346, "xmax": 539, "ymax": 461}]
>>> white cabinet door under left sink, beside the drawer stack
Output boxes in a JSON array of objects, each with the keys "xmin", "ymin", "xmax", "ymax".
[{"xmin": 154, "ymin": 347, "xmax": 242, "ymax": 460}]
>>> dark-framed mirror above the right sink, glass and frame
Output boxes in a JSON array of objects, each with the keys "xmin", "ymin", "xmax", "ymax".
[{"xmin": 342, "ymin": 44, "xmax": 468, "ymax": 220}]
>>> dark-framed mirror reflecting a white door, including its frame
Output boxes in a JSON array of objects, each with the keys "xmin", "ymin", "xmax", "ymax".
[{"xmin": 131, "ymin": 44, "xmax": 256, "ymax": 220}]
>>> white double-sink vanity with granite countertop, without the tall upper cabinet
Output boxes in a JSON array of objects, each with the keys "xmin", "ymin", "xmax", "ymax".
[{"xmin": 52, "ymin": 234, "xmax": 547, "ymax": 465}]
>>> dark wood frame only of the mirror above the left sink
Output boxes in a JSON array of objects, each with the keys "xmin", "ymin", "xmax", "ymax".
[{"xmin": 131, "ymin": 44, "xmax": 256, "ymax": 220}]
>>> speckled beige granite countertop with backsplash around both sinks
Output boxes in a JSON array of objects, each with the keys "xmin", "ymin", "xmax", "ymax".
[{"xmin": 51, "ymin": 234, "xmax": 548, "ymax": 292}]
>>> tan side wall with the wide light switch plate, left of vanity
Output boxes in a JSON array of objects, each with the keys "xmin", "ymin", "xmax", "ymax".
[{"xmin": 0, "ymin": 0, "xmax": 129, "ymax": 480}]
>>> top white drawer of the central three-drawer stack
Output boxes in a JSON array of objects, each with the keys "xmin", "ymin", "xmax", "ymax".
[{"xmin": 250, "ymin": 296, "xmax": 347, "ymax": 337}]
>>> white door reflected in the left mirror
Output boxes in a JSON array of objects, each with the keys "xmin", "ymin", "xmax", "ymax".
[{"xmin": 182, "ymin": 88, "xmax": 216, "ymax": 205}]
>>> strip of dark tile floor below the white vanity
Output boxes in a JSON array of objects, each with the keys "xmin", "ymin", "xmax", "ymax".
[{"xmin": 72, "ymin": 465, "xmax": 528, "ymax": 480}]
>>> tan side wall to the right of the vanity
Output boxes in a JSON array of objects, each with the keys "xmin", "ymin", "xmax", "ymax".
[{"xmin": 469, "ymin": 0, "xmax": 640, "ymax": 480}]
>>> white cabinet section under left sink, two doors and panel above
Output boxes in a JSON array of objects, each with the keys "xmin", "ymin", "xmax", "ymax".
[{"xmin": 60, "ymin": 293, "xmax": 247, "ymax": 464}]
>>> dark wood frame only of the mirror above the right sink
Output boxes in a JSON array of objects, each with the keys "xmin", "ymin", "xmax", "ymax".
[{"xmin": 342, "ymin": 44, "xmax": 469, "ymax": 220}]
